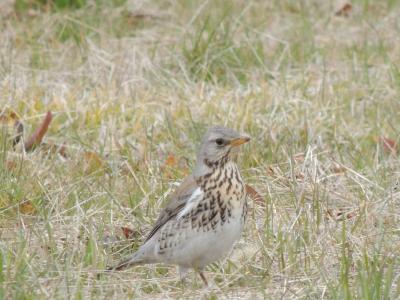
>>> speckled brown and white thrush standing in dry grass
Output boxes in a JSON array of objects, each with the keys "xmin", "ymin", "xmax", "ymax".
[{"xmin": 107, "ymin": 126, "xmax": 250, "ymax": 286}]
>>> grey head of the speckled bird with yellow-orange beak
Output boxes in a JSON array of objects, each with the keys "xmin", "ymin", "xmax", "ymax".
[{"xmin": 196, "ymin": 126, "xmax": 250, "ymax": 173}]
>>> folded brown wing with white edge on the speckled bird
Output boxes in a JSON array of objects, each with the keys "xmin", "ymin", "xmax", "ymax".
[{"xmin": 145, "ymin": 175, "xmax": 202, "ymax": 242}]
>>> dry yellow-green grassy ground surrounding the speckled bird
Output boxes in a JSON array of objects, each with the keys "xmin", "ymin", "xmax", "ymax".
[{"xmin": 0, "ymin": 0, "xmax": 400, "ymax": 299}]
